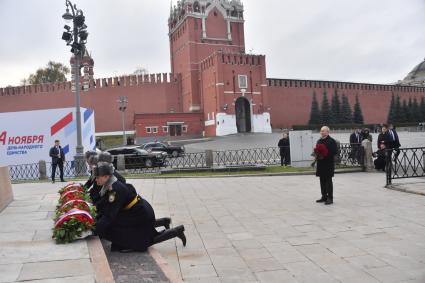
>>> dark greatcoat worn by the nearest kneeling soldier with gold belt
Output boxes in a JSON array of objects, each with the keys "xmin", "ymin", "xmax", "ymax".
[{"xmin": 96, "ymin": 181, "xmax": 159, "ymax": 252}]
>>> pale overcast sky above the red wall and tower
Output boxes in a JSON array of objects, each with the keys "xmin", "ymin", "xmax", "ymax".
[{"xmin": 0, "ymin": 0, "xmax": 425, "ymax": 87}]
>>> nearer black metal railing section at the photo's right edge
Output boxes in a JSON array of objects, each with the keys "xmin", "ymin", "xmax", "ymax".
[{"xmin": 385, "ymin": 147, "xmax": 425, "ymax": 186}]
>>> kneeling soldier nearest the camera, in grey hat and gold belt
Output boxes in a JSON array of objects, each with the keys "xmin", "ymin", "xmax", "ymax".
[{"xmin": 93, "ymin": 162, "xmax": 182, "ymax": 252}]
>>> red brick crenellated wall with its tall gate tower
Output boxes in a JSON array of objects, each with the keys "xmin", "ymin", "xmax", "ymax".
[{"xmin": 0, "ymin": 0, "xmax": 425, "ymax": 142}]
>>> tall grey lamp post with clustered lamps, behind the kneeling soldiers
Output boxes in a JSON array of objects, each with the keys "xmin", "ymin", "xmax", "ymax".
[{"xmin": 62, "ymin": 0, "xmax": 88, "ymax": 176}]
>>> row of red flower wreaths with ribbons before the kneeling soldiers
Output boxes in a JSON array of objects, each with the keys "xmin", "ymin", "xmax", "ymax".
[{"xmin": 52, "ymin": 184, "xmax": 96, "ymax": 244}]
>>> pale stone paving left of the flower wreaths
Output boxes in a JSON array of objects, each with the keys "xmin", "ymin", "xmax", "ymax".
[{"xmin": 0, "ymin": 183, "xmax": 95, "ymax": 283}]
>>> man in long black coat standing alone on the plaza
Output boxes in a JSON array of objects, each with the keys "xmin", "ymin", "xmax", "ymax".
[{"xmin": 316, "ymin": 126, "xmax": 337, "ymax": 205}]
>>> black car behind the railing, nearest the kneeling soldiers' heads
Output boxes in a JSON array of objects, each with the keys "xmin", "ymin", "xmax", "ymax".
[{"xmin": 106, "ymin": 146, "xmax": 167, "ymax": 169}]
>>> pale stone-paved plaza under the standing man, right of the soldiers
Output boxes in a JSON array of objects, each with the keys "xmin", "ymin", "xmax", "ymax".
[{"xmin": 129, "ymin": 173, "xmax": 425, "ymax": 283}]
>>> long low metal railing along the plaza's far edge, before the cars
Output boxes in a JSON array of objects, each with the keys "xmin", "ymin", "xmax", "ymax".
[{"xmin": 10, "ymin": 144, "xmax": 364, "ymax": 181}]
